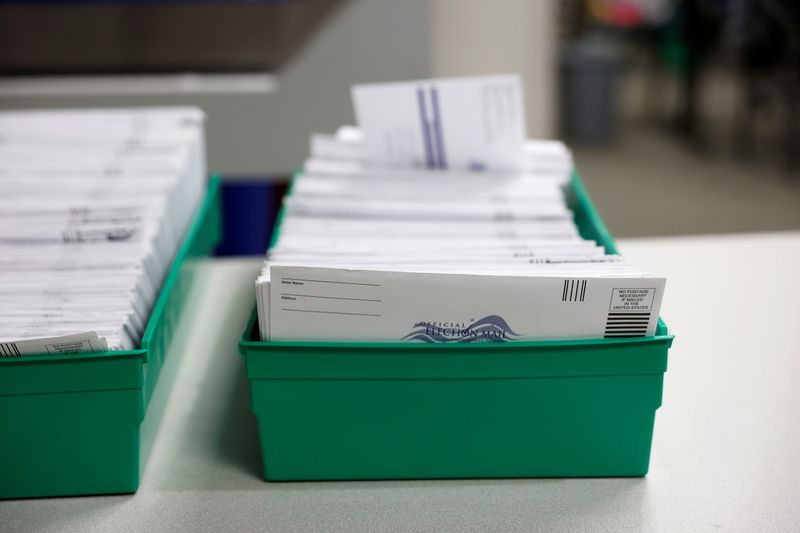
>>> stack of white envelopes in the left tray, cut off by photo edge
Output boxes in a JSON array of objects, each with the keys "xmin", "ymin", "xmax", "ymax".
[{"xmin": 0, "ymin": 108, "xmax": 206, "ymax": 357}]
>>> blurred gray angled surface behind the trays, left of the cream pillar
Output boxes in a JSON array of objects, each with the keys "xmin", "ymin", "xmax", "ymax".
[{"xmin": 0, "ymin": 0, "xmax": 430, "ymax": 174}]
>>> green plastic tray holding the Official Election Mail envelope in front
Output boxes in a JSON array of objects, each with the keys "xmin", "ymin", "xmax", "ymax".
[{"xmin": 239, "ymin": 174, "xmax": 673, "ymax": 481}]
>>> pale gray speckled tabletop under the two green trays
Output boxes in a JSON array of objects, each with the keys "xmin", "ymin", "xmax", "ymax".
[{"xmin": 0, "ymin": 233, "xmax": 800, "ymax": 532}]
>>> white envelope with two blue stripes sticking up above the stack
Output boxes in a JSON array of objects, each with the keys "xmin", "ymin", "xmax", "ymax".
[{"xmin": 352, "ymin": 75, "xmax": 527, "ymax": 170}]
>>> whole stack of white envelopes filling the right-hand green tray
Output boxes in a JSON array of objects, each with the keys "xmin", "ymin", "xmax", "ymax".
[{"xmin": 256, "ymin": 76, "xmax": 665, "ymax": 343}]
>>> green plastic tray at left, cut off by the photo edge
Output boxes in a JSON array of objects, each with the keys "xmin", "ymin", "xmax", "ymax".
[{"xmin": 0, "ymin": 177, "xmax": 221, "ymax": 499}]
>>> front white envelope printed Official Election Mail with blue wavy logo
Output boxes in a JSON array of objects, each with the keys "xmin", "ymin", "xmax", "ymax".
[{"xmin": 269, "ymin": 266, "xmax": 665, "ymax": 343}]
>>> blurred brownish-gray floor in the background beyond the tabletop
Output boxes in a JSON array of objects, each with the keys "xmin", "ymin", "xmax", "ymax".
[{"xmin": 573, "ymin": 67, "xmax": 800, "ymax": 237}]
